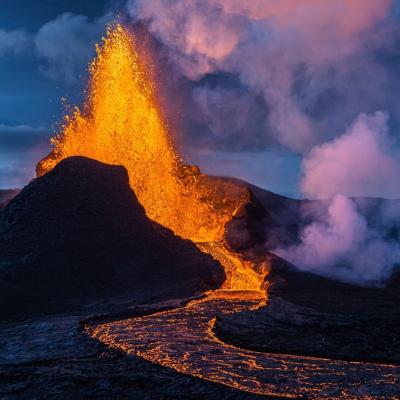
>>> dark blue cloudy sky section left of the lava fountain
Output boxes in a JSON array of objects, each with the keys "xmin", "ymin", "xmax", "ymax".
[{"xmin": 0, "ymin": 0, "xmax": 116, "ymax": 188}]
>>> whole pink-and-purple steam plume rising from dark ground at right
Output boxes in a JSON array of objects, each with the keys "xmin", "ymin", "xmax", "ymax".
[{"xmin": 276, "ymin": 112, "xmax": 400, "ymax": 285}]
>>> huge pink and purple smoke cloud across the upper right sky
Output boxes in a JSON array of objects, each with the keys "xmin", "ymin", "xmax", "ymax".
[{"xmin": 127, "ymin": 0, "xmax": 399, "ymax": 153}]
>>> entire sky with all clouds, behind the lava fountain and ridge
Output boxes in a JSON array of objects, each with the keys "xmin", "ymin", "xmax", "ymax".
[{"xmin": 0, "ymin": 0, "xmax": 400, "ymax": 198}]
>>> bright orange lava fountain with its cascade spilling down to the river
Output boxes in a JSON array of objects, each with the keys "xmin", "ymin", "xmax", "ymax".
[{"xmin": 37, "ymin": 24, "xmax": 267, "ymax": 293}]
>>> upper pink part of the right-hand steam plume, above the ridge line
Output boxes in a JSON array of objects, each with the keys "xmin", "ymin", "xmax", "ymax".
[{"xmin": 301, "ymin": 112, "xmax": 400, "ymax": 198}]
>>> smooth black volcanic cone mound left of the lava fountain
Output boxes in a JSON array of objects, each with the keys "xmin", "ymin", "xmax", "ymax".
[{"xmin": 0, "ymin": 157, "xmax": 224, "ymax": 315}]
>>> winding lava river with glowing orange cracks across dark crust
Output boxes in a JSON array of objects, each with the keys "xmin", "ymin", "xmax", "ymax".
[{"xmin": 90, "ymin": 291, "xmax": 400, "ymax": 399}]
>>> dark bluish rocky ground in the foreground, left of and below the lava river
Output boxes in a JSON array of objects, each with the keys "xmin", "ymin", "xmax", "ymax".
[{"xmin": 0, "ymin": 292, "xmax": 265, "ymax": 400}]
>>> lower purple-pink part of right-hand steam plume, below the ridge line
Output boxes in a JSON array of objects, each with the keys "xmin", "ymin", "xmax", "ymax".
[{"xmin": 275, "ymin": 195, "xmax": 400, "ymax": 285}]
